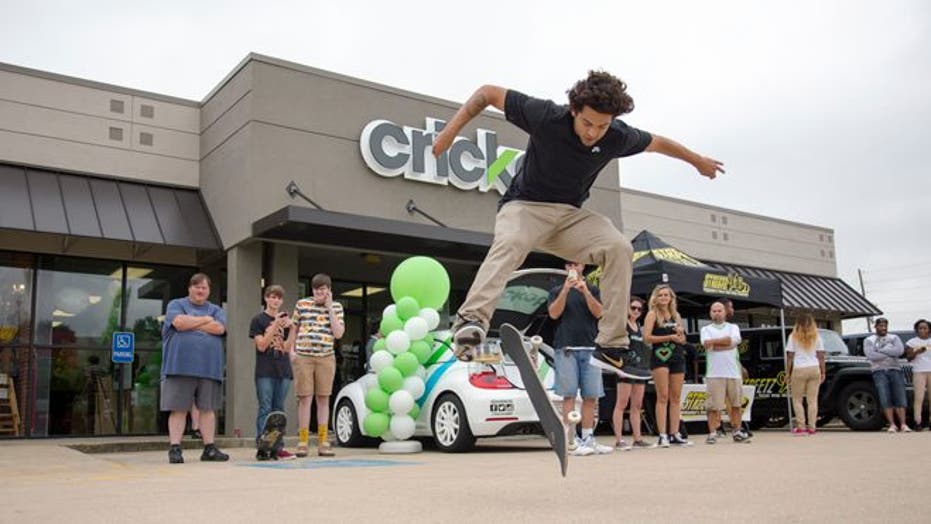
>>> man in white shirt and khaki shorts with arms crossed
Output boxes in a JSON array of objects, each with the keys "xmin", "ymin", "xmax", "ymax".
[{"xmin": 701, "ymin": 302, "xmax": 750, "ymax": 444}]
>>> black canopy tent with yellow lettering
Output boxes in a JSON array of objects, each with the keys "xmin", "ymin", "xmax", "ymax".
[{"xmin": 630, "ymin": 230, "xmax": 782, "ymax": 317}]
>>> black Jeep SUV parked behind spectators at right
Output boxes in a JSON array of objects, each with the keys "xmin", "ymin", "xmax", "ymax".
[{"xmin": 689, "ymin": 328, "xmax": 912, "ymax": 430}]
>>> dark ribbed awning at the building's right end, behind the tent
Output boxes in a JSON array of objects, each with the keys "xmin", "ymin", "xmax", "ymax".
[{"xmin": 706, "ymin": 261, "xmax": 882, "ymax": 319}]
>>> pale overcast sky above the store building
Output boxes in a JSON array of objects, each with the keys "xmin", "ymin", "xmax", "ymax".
[{"xmin": 0, "ymin": 0, "xmax": 931, "ymax": 329}]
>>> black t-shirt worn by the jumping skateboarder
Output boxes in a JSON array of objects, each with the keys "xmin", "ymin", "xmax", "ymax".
[{"xmin": 501, "ymin": 90, "xmax": 653, "ymax": 207}]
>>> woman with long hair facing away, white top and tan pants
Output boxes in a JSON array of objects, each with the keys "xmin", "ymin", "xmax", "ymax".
[{"xmin": 786, "ymin": 313, "xmax": 824, "ymax": 435}]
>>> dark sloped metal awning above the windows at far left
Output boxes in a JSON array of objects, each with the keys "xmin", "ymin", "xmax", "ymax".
[{"xmin": 0, "ymin": 164, "xmax": 220, "ymax": 250}]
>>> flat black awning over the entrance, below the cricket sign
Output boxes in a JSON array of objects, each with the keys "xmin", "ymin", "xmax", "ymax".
[{"xmin": 252, "ymin": 206, "xmax": 562, "ymax": 267}]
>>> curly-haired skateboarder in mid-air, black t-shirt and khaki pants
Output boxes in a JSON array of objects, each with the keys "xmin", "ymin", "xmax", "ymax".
[{"xmin": 433, "ymin": 71, "xmax": 724, "ymax": 369}]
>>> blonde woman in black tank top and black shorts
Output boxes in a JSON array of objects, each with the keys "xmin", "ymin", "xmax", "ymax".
[{"xmin": 643, "ymin": 284, "xmax": 692, "ymax": 448}]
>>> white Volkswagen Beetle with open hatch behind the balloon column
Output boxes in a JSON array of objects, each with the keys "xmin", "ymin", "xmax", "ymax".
[{"xmin": 333, "ymin": 269, "xmax": 566, "ymax": 452}]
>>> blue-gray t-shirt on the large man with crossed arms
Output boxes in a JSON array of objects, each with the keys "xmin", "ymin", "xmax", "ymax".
[{"xmin": 162, "ymin": 297, "xmax": 226, "ymax": 382}]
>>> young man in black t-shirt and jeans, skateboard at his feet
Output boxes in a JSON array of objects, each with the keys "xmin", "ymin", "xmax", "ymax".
[{"xmin": 249, "ymin": 285, "xmax": 297, "ymax": 460}]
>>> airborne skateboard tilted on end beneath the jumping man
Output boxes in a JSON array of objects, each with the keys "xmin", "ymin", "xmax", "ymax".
[{"xmin": 499, "ymin": 324, "xmax": 569, "ymax": 477}]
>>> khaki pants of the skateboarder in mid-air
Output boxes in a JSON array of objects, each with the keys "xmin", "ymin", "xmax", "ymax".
[{"xmin": 459, "ymin": 200, "xmax": 633, "ymax": 347}]
